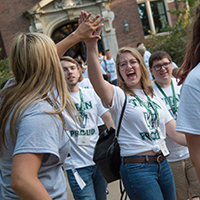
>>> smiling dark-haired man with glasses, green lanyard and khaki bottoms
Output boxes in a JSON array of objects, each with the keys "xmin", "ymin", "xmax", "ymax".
[{"xmin": 149, "ymin": 51, "xmax": 200, "ymax": 200}]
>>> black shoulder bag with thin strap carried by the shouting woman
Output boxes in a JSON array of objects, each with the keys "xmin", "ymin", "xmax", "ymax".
[{"xmin": 93, "ymin": 95, "xmax": 127, "ymax": 183}]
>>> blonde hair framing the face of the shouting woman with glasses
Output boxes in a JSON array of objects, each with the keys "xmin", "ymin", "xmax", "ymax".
[{"xmin": 116, "ymin": 47, "xmax": 154, "ymax": 97}]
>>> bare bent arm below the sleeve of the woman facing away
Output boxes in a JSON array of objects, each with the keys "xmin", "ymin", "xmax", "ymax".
[{"xmin": 10, "ymin": 153, "xmax": 53, "ymax": 200}]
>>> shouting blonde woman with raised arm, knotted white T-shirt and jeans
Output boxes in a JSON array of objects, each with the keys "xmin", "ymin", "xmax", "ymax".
[{"xmin": 79, "ymin": 10, "xmax": 187, "ymax": 200}]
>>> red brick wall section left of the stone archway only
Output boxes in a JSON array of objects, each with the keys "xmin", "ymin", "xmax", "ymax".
[{"xmin": 0, "ymin": 0, "xmax": 40, "ymax": 58}]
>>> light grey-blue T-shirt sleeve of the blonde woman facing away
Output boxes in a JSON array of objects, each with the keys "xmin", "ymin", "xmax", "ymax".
[{"xmin": 13, "ymin": 102, "xmax": 63, "ymax": 158}]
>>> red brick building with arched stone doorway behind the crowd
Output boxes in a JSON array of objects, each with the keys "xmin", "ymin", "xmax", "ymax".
[{"xmin": 0, "ymin": 0, "xmax": 180, "ymax": 58}]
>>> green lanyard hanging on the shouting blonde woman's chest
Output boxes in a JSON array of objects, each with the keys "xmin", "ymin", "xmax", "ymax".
[{"xmin": 135, "ymin": 92, "xmax": 159, "ymax": 130}]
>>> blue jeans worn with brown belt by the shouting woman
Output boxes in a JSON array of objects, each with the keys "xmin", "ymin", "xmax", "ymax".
[{"xmin": 120, "ymin": 156, "xmax": 176, "ymax": 200}]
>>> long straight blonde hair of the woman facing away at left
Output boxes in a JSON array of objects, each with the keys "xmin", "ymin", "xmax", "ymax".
[{"xmin": 0, "ymin": 33, "xmax": 75, "ymax": 155}]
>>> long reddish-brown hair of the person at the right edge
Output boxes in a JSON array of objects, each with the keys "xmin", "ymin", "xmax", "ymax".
[{"xmin": 177, "ymin": 3, "xmax": 200, "ymax": 85}]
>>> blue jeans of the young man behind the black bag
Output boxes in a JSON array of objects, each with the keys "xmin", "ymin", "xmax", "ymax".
[{"xmin": 67, "ymin": 165, "xmax": 107, "ymax": 200}]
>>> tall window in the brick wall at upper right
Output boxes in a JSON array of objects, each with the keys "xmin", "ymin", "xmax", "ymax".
[{"xmin": 138, "ymin": 0, "xmax": 168, "ymax": 35}]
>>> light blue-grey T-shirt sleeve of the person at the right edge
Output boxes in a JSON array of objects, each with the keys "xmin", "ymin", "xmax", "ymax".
[{"xmin": 176, "ymin": 84, "xmax": 200, "ymax": 135}]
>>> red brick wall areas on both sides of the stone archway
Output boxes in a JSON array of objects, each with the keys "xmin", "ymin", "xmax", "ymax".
[{"xmin": 0, "ymin": 0, "xmax": 186, "ymax": 59}]
